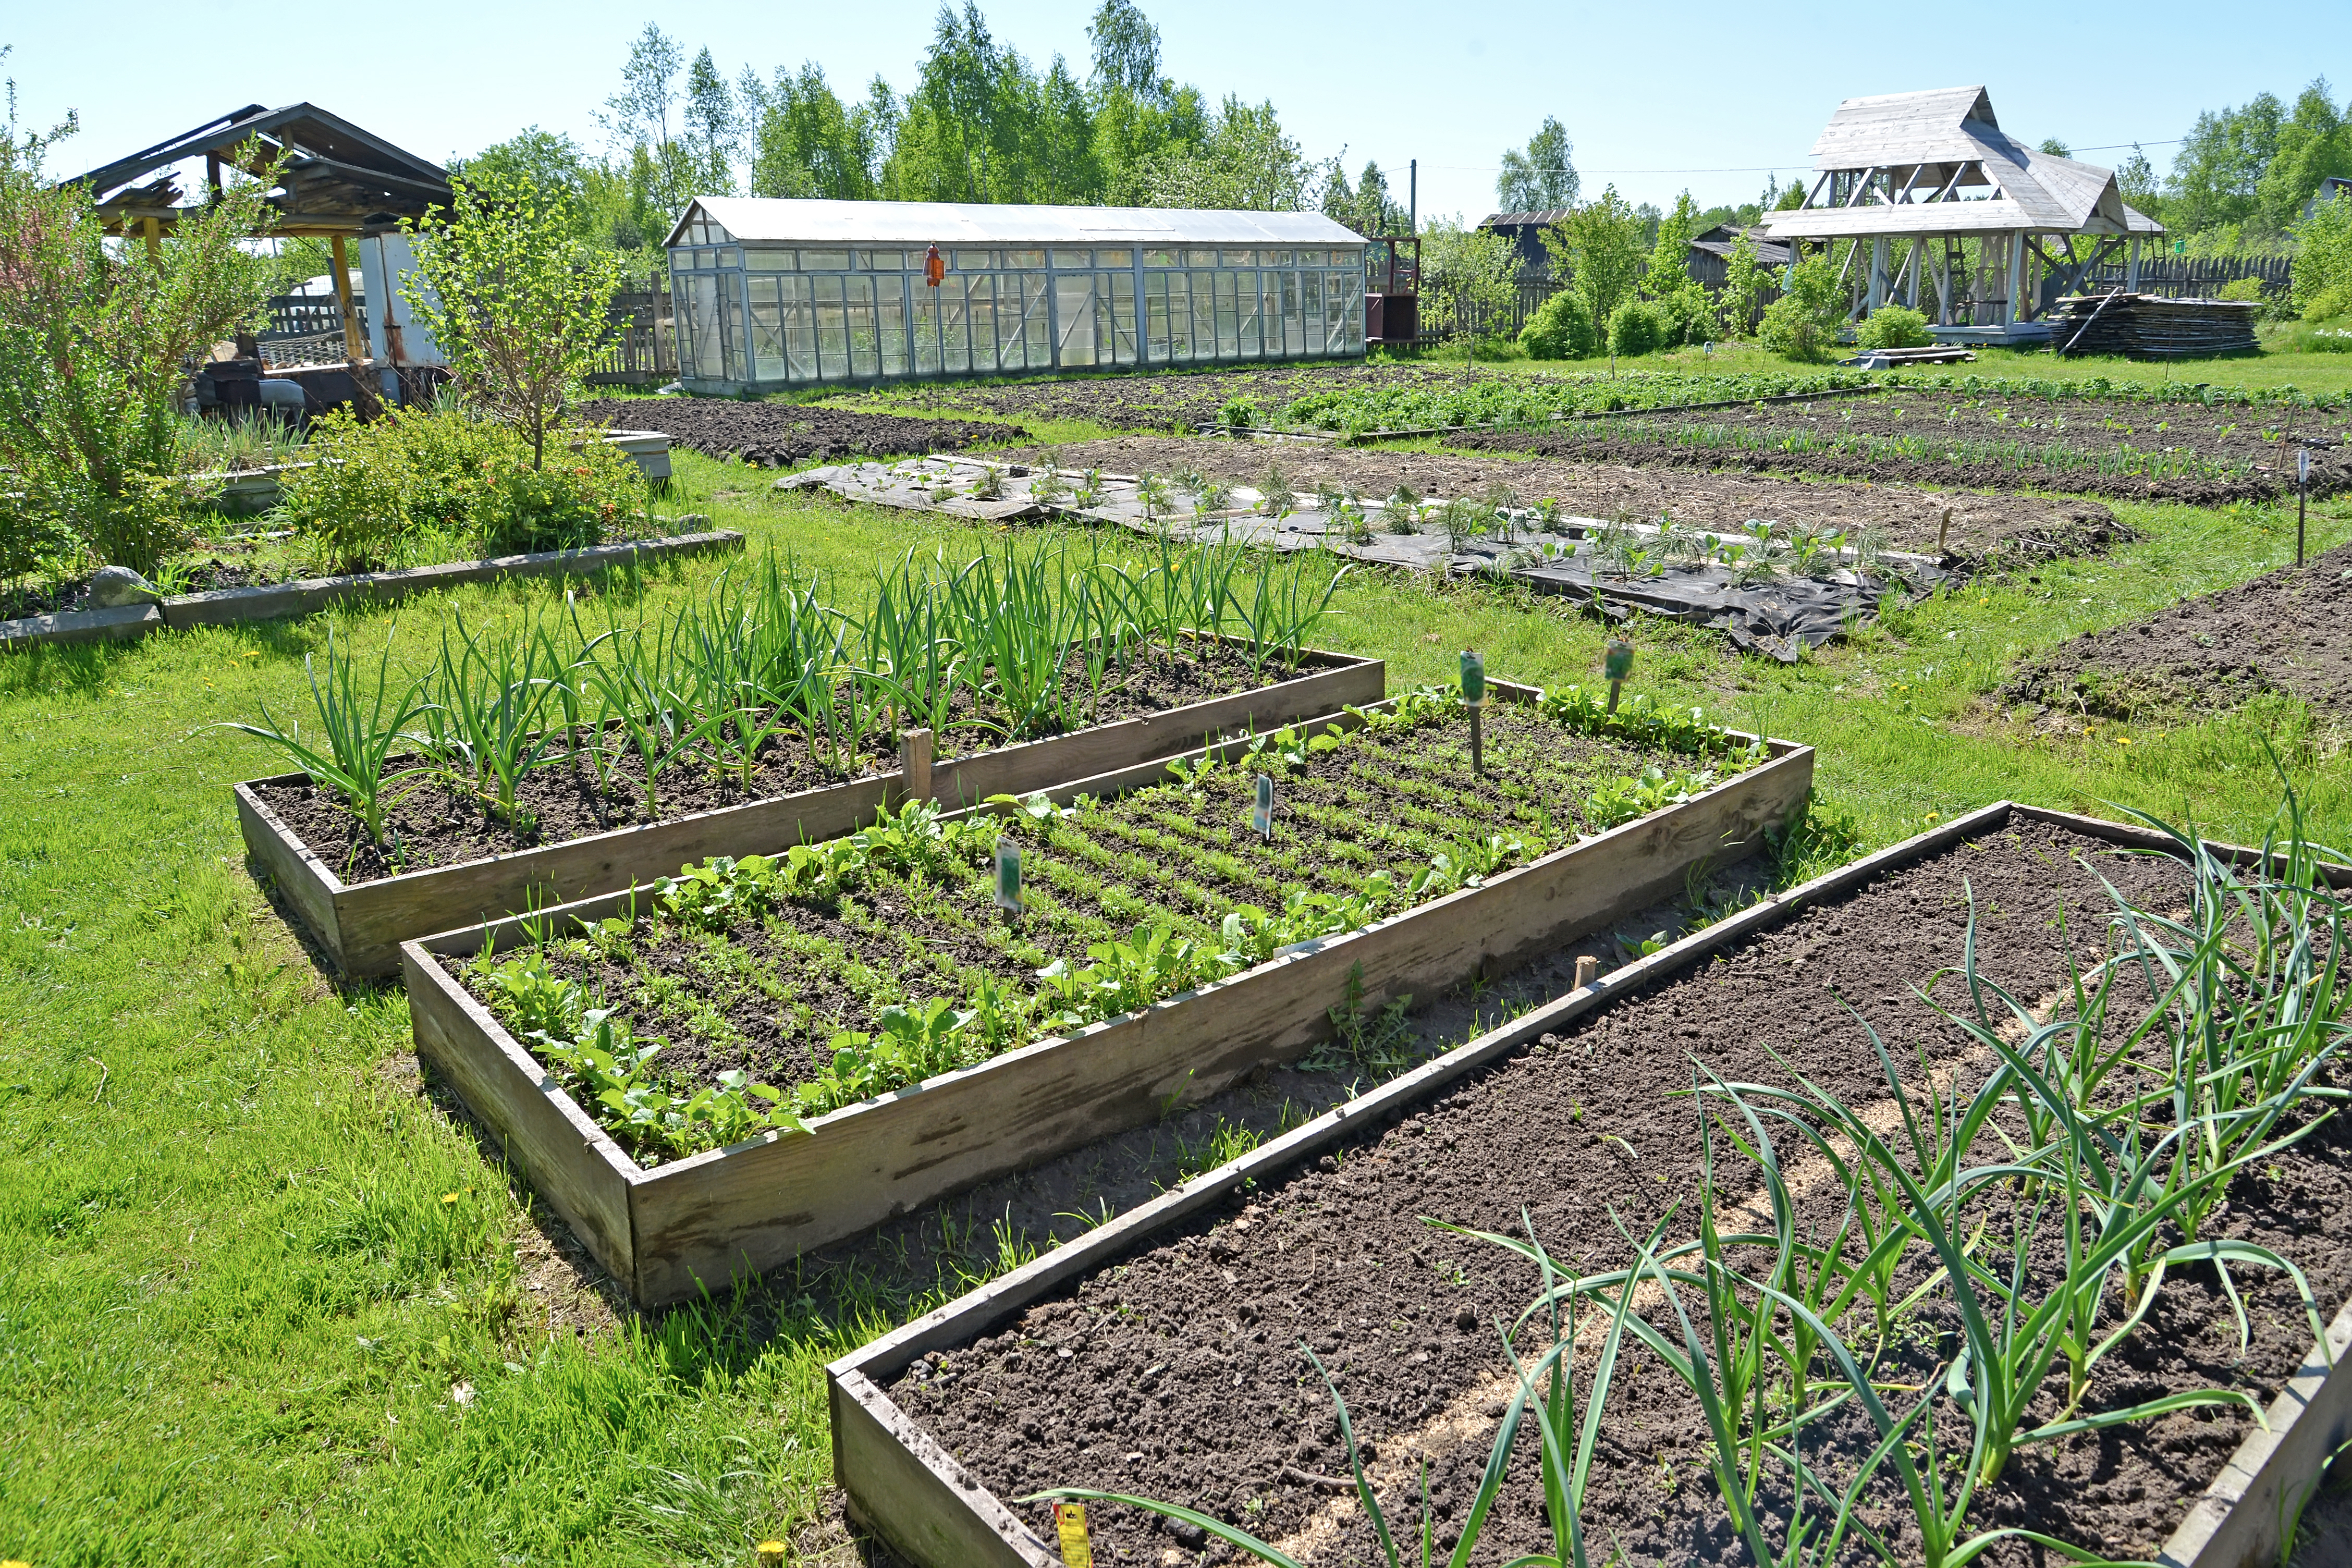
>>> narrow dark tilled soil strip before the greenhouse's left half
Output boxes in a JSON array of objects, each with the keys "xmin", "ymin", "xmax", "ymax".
[{"xmin": 579, "ymin": 397, "xmax": 1028, "ymax": 468}]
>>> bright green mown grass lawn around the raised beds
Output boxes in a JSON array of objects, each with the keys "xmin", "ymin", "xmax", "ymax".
[{"xmin": 0, "ymin": 454, "xmax": 2352, "ymax": 1568}]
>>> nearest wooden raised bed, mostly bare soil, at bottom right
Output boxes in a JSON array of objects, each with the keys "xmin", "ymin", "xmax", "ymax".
[{"xmin": 828, "ymin": 804, "xmax": 2352, "ymax": 1568}]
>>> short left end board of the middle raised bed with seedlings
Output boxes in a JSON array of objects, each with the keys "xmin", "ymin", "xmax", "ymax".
[{"xmin": 407, "ymin": 940, "xmax": 638, "ymax": 1279}]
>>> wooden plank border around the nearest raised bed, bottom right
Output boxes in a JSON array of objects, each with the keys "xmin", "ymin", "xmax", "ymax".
[{"xmin": 826, "ymin": 802, "xmax": 2352, "ymax": 1568}]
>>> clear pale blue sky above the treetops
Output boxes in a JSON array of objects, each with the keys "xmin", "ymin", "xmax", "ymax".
[{"xmin": 0, "ymin": 0, "xmax": 2352, "ymax": 218}]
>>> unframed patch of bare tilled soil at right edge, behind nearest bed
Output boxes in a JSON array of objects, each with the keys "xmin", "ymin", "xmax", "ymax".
[{"xmin": 2008, "ymin": 545, "xmax": 2352, "ymax": 724}]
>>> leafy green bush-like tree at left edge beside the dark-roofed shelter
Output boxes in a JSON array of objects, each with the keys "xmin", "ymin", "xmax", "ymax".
[{"xmin": 0, "ymin": 66, "xmax": 273, "ymax": 573}]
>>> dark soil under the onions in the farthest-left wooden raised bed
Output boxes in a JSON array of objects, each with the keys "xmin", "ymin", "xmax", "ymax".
[{"xmin": 256, "ymin": 649, "xmax": 1289, "ymax": 881}]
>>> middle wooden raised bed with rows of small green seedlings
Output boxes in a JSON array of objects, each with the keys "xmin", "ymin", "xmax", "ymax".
[{"xmin": 402, "ymin": 687, "xmax": 1814, "ymax": 1302}]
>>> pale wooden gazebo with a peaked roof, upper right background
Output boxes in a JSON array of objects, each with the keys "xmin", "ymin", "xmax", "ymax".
[{"xmin": 1764, "ymin": 87, "xmax": 2164, "ymax": 343}]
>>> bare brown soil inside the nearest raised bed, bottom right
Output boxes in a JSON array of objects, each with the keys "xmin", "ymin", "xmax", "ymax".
[{"xmin": 891, "ymin": 823, "xmax": 2352, "ymax": 1565}]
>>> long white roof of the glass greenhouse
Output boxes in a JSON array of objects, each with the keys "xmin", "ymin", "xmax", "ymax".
[{"xmin": 663, "ymin": 195, "xmax": 1364, "ymax": 247}]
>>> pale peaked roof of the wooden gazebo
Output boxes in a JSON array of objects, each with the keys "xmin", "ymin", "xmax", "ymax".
[{"xmin": 1764, "ymin": 87, "xmax": 2164, "ymax": 240}]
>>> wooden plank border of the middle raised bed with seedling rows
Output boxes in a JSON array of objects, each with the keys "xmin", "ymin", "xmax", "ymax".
[{"xmin": 400, "ymin": 684, "xmax": 1814, "ymax": 1305}]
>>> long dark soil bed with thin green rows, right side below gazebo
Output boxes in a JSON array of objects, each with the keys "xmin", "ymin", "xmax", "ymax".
[{"xmin": 1447, "ymin": 393, "xmax": 2352, "ymax": 506}]
